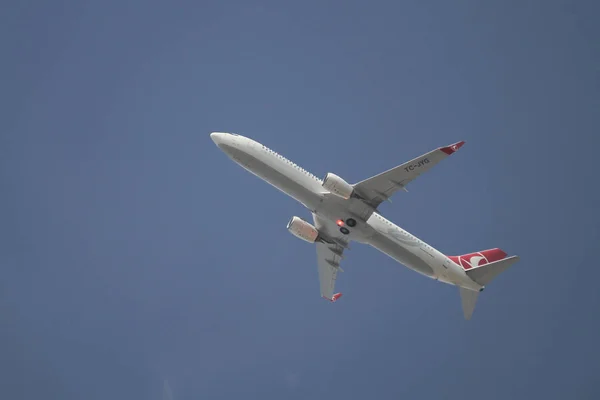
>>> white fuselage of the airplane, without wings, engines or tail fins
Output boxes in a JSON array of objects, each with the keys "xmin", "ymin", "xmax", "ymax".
[{"xmin": 211, "ymin": 132, "xmax": 482, "ymax": 290}]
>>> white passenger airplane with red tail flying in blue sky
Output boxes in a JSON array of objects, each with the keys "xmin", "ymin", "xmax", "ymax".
[{"xmin": 210, "ymin": 132, "xmax": 519, "ymax": 320}]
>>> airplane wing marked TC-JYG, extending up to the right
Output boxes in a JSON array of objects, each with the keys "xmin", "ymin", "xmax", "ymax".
[{"xmin": 353, "ymin": 142, "xmax": 465, "ymax": 208}]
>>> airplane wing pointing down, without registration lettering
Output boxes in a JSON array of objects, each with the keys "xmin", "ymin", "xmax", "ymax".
[{"xmin": 313, "ymin": 214, "xmax": 348, "ymax": 301}]
